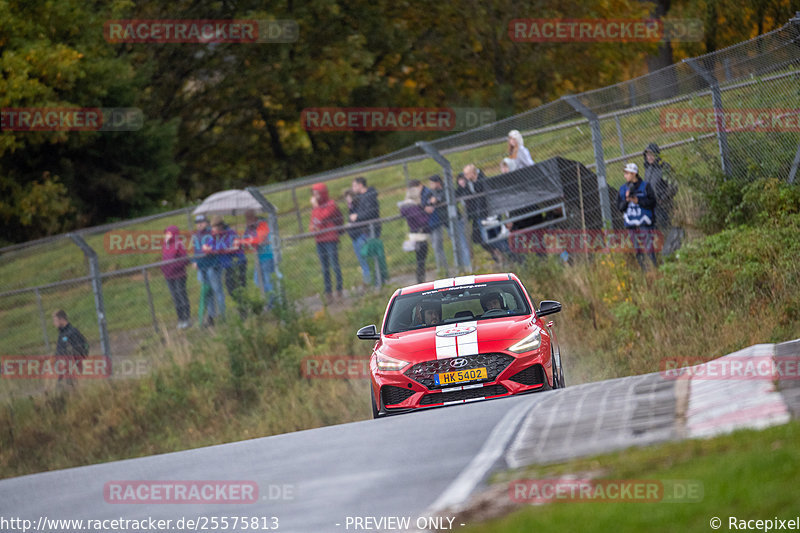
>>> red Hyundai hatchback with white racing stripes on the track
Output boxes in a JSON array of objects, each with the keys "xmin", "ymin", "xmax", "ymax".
[{"xmin": 357, "ymin": 274, "xmax": 565, "ymax": 418}]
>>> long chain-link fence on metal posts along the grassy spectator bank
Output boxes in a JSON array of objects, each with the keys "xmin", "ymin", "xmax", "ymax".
[{"xmin": 0, "ymin": 15, "xmax": 800, "ymax": 362}]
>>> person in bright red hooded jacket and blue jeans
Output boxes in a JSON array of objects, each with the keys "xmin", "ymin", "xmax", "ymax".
[{"xmin": 308, "ymin": 183, "xmax": 344, "ymax": 300}]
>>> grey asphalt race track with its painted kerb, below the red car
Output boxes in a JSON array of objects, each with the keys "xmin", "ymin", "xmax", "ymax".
[{"xmin": 0, "ymin": 343, "xmax": 797, "ymax": 533}]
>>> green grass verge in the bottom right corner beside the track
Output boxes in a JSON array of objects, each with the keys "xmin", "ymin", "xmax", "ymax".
[{"xmin": 461, "ymin": 421, "xmax": 800, "ymax": 533}]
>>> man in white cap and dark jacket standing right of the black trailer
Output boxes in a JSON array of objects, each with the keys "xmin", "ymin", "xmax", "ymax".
[{"xmin": 617, "ymin": 163, "xmax": 658, "ymax": 270}]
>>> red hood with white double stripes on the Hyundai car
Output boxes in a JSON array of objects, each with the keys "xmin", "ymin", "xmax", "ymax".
[{"xmin": 377, "ymin": 315, "xmax": 546, "ymax": 362}]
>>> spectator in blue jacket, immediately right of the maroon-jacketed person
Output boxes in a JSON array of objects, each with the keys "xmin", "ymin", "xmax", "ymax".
[{"xmin": 192, "ymin": 215, "xmax": 225, "ymax": 326}]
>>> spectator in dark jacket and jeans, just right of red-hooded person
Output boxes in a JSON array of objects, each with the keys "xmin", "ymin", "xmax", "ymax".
[{"xmin": 350, "ymin": 176, "xmax": 389, "ymax": 287}]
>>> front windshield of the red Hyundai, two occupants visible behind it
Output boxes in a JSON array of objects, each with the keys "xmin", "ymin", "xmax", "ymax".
[{"xmin": 384, "ymin": 280, "xmax": 531, "ymax": 334}]
